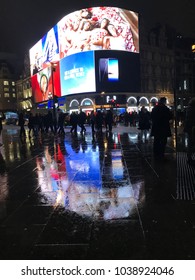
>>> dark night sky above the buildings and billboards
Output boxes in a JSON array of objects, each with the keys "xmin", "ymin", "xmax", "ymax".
[{"xmin": 0, "ymin": 0, "xmax": 195, "ymax": 54}]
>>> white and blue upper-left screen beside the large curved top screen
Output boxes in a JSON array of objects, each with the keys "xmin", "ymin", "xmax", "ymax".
[{"xmin": 29, "ymin": 25, "xmax": 59, "ymax": 76}]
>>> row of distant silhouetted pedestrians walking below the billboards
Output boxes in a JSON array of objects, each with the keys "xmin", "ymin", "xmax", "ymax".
[{"xmin": 18, "ymin": 110, "xmax": 117, "ymax": 138}]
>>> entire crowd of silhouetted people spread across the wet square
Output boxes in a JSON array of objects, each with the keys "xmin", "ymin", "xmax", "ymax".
[{"xmin": 0, "ymin": 97, "xmax": 195, "ymax": 166}]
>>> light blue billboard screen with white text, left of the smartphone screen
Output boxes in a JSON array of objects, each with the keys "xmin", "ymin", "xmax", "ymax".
[{"xmin": 60, "ymin": 51, "xmax": 96, "ymax": 96}]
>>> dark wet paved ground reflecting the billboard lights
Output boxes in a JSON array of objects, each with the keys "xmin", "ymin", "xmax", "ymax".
[{"xmin": 0, "ymin": 124, "xmax": 195, "ymax": 260}]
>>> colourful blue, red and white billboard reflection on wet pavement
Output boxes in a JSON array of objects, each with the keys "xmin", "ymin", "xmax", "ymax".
[{"xmin": 34, "ymin": 133, "xmax": 144, "ymax": 220}]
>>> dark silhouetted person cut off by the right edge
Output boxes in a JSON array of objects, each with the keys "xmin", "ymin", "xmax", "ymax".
[{"xmin": 184, "ymin": 98, "xmax": 195, "ymax": 166}]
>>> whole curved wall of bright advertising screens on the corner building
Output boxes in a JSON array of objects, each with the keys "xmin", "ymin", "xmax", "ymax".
[{"xmin": 29, "ymin": 7, "xmax": 139, "ymax": 102}]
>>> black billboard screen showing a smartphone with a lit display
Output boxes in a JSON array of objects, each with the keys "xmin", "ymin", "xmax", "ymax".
[{"xmin": 95, "ymin": 50, "xmax": 140, "ymax": 92}]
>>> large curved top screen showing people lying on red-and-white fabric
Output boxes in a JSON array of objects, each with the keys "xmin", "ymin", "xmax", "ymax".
[{"xmin": 57, "ymin": 7, "xmax": 139, "ymax": 59}]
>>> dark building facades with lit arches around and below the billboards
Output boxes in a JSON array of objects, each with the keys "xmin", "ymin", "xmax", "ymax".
[{"xmin": 0, "ymin": 19, "xmax": 195, "ymax": 114}]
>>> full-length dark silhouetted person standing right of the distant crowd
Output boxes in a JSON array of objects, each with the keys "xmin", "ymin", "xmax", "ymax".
[{"xmin": 151, "ymin": 97, "xmax": 173, "ymax": 158}]
